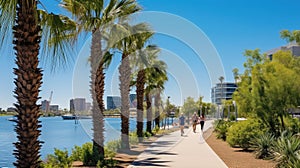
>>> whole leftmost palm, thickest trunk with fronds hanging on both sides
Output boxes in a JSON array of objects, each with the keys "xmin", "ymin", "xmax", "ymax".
[{"xmin": 0, "ymin": 0, "xmax": 76, "ymax": 167}]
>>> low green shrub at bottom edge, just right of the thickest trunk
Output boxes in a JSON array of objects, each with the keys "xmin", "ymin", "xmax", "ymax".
[{"xmin": 41, "ymin": 148, "xmax": 73, "ymax": 168}]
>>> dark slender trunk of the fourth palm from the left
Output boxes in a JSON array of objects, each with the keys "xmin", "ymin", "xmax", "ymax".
[{"xmin": 136, "ymin": 69, "xmax": 145, "ymax": 141}]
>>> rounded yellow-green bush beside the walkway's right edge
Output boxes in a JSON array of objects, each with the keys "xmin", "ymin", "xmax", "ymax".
[{"xmin": 226, "ymin": 119, "xmax": 263, "ymax": 150}]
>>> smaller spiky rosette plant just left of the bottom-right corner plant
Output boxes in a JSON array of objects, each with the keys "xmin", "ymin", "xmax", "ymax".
[{"xmin": 251, "ymin": 132, "xmax": 275, "ymax": 159}]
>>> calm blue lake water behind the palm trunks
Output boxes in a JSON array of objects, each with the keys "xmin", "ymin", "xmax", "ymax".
[{"xmin": 0, "ymin": 116, "xmax": 145, "ymax": 167}]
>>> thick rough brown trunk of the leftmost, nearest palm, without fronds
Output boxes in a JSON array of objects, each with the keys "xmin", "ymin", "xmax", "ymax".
[{"xmin": 13, "ymin": 0, "xmax": 42, "ymax": 168}]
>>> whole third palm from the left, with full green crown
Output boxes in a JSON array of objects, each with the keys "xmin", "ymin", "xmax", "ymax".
[{"xmin": 108, "ymin": 20, "xmax": 150, "ymax": 149}]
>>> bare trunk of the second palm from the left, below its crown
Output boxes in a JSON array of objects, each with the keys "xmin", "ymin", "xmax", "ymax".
[{"xmin": 90, "ymin": 30, "xmax": 105, "ymax": 159}]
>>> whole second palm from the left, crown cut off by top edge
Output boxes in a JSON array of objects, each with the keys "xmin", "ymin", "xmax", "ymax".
[{"xmin": 63, "ymin": 0, "xmax": 140, "ymax": 159}]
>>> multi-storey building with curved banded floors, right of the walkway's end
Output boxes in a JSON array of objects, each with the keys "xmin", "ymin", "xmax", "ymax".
[{"xmin": 211, "ymin": 82, "xmax": 237, "ymax": 105}]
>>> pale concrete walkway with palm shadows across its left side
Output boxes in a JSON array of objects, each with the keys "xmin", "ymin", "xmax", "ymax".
[{"xmin": 128, "ymin": 121, "xmax": 227, "ymax": 168}]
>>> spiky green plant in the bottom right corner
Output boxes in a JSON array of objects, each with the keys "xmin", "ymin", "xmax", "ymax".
[{"xmin": 274, "ymin": 131, "xmax": 300, "ymax": 167}]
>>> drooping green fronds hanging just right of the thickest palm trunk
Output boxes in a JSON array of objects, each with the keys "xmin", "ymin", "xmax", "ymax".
[{"xmin": 38, "ymin": 10, "xmax": 78, "ymax": 70}]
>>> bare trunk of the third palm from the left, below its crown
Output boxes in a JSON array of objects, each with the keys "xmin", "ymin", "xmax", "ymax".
[{"xmin": 119, "ymin": 53, "xmax": 131, "ymax": 149}]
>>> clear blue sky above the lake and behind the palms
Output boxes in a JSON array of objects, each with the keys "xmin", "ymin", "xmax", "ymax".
[{"xmin": 0, "ymin": 0, "xmax": 300, "ymax": 109}]
